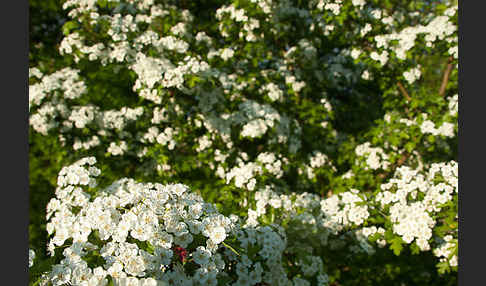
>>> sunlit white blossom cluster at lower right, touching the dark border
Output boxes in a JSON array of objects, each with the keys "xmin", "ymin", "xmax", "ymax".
[{"xmin": 376, "ymin": 161, "xmax": 458, "ymax": 250}]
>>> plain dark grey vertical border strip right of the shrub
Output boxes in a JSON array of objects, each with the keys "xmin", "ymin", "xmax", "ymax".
[{"xmin": 458, "ymin": 0, "xmax": 478, "ymax": 285}]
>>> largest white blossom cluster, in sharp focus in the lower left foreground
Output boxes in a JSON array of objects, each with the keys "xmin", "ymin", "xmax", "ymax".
[{"xmin": 42, "ymin": 157, "xmax": 240, "ymax": 285}]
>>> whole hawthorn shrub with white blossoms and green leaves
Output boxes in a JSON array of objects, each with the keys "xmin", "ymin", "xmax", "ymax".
[{"xmin": 29, "ymin": 0, "xmax": 459, "ymax": 285}]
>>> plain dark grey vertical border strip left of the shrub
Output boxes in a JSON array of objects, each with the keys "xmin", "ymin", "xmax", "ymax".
[{"xmin": 0, "ymin": 0, "xmax": 29, "ymax": 285}]
